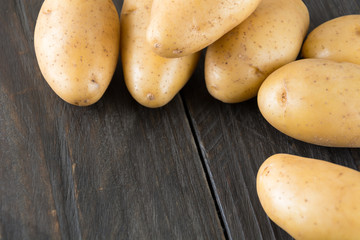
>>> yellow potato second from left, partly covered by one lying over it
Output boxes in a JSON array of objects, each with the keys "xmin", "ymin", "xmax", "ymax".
[{"xmin": 120, "ymin": 0, "xmax": 200, "ymax": 108}]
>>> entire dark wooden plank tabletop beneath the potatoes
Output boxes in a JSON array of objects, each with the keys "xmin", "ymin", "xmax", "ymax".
[{"xmin": 0, "ymin": 0, "xmax": 360, "ymax": 240}]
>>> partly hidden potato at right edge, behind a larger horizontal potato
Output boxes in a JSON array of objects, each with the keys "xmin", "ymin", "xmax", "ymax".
[{"xmin": 302, "ymin": 14, "xmax": 360, "ymax": 64}]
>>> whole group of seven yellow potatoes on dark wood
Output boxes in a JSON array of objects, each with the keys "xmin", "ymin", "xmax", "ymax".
[{"xmin": 34, "ymin": 0, "xmax": 360, "ymax": 239}]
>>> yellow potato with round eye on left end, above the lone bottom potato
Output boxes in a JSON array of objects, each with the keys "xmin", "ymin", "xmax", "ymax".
[{"xmin": 258, "ymin": 59, "xmax": 360, "ymax": 147}]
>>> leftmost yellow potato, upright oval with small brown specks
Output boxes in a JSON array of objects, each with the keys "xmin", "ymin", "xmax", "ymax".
[{"xmin": 34, "ymin": 0, "xmax": 120, "ymax": 106}]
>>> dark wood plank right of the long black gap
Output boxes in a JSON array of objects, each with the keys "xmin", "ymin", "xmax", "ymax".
[{"xmin": 182, "ymin": 0, "xmax": 360, "ymax": 239}]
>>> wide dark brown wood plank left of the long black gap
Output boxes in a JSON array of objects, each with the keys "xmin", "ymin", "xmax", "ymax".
[{"xmin": 0, "ymin": 0, "xmax": 224, "ymax": 239}]
